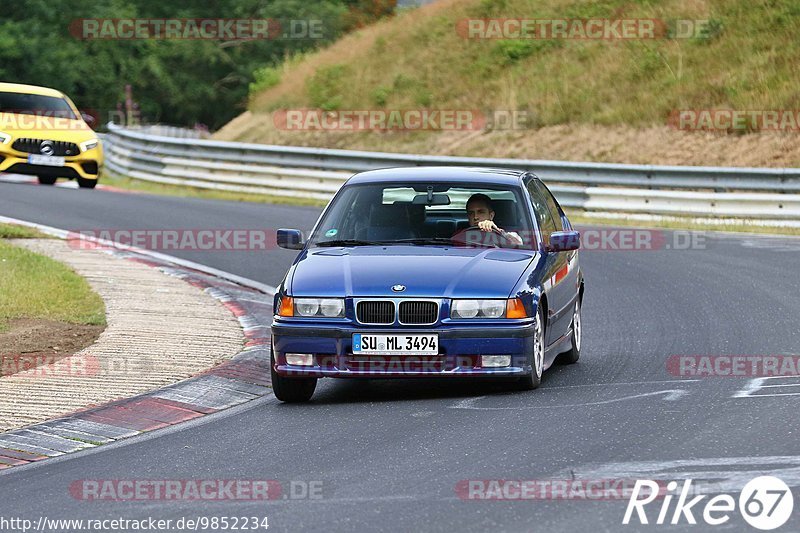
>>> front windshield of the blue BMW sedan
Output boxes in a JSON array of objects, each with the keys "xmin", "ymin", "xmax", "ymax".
[{"xmin": 310, "ymin": 182, "xmax": 535, "ymax": 248}]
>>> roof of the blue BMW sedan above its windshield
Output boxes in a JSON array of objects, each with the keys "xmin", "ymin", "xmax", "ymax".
[{"xmin": 347, "ymin": 167, "xmax": 526, "ymax": 185}]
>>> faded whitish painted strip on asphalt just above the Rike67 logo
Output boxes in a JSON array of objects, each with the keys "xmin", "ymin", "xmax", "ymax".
[{"xmin": 555, "ymin": 455, "xmax": 800, "ymax": 493}]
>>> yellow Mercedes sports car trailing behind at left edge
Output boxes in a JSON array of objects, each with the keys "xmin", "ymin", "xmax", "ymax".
[{"xmin": 0, "ymin": 83, "xmax": 103, "ymax": 189}]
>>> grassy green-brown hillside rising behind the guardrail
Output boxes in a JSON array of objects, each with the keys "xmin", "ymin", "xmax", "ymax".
[{"xmin": 217, "ymin": 0, "xmax": 800, "ymax": 164}]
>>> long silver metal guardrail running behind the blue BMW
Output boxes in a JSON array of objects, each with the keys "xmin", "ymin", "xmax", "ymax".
[{"xmin": 104, "ymin": 124, "xmax": 800, "ymax": 221}]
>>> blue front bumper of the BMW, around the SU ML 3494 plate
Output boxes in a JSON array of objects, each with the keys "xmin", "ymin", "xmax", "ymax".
[{"xmin": 272, "ymin": 318, "xmax": 534, "ymax": 378}]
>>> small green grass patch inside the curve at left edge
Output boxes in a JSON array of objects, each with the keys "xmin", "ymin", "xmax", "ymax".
[{"xmin": 0, "ymin": 233, "xmax": 106, "ymax": 332}]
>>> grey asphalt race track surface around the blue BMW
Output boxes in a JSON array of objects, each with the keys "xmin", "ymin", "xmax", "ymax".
[{"xmin": 0, "ymin": 183, "xmax": 800, "ymax": 531}]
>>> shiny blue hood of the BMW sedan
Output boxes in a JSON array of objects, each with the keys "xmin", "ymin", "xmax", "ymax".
[{"xmin": 287, "ymin": 246, "xmax": 537, "ymax": 298}]
